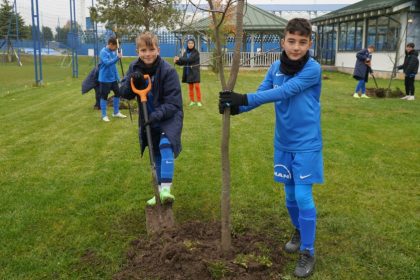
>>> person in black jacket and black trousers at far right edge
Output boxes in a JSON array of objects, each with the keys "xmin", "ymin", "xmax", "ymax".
[{"xmin": 397, "ymin": 43, "xmax": 419, "ymax": 100}]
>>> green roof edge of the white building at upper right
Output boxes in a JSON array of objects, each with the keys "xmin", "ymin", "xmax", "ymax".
[{"xmin": 311, "ymin": 0, "xmax": 416, "ymax": 24}]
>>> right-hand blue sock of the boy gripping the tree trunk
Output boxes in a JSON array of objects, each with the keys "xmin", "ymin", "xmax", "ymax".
[{"xmin": 299, "ymin": 208, "xmax": 316, "ymax": 256}]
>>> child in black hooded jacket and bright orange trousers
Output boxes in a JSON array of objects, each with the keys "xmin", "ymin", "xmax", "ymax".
[{"xmin": 174, "ymin": 39, "xmax": 202, "ymax": 107}]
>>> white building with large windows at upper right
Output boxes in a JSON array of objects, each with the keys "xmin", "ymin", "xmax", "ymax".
[{"xmin": 311, "ymin": 0, "xmax": 420, "ymax": 78}]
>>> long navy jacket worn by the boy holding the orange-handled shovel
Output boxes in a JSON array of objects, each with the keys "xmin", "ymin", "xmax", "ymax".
[{"xmin": 120, "ymin": 59, "xmax": 184, "ymax": 157}]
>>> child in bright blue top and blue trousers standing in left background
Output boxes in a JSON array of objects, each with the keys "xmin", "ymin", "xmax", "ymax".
[{"xmin": 98, "ymin": 37, "xmax": 126, "ymax": 122}]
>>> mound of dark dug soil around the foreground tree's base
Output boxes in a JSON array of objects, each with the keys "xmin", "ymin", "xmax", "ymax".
[{"xmin": 113, "ymin": 222, "xmax": 286, "ymax": 280}]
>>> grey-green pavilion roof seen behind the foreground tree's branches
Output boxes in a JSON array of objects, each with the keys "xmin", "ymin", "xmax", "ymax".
[{"xmin": 175, "ymin": 4, "xmax": 287, "ymax": 33}]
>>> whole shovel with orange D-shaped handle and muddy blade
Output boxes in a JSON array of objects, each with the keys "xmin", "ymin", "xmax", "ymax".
[{"xmin": 130, "ymin": 75, "xmax": 175, "ymax": 234}]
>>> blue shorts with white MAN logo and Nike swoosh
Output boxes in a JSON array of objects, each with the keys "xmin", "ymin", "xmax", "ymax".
[{"xmin": 274, "ymin": 150, "xmax": 324, "ymax": 185}]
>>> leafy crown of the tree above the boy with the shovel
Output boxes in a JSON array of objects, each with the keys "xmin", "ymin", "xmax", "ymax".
[{"xmin": 90, "ymin": 0, "xmax": 180, "ymax": 33}]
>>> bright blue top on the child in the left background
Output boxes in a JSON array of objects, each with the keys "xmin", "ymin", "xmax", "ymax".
[{"xmin": 98, "ymin": 47, "xmax": 120, "ymax": 83}]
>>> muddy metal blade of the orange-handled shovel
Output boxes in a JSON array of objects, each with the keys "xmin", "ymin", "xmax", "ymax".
[{"xmin": 146, "ymin": 204, "xmax": 175, "ymax": 234}]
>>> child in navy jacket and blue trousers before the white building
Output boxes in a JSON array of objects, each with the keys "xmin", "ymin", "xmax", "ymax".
[{"xmin": 353, "ymin": 45, "xmax": 375, "ymax": 98}]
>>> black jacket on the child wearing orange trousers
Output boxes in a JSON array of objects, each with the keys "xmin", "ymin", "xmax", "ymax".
[{"xmin": 176, "ymin": 48, "xmax": 200, "ymax": 84}]
